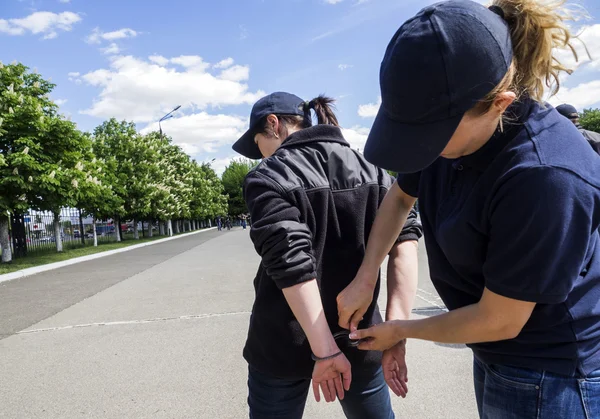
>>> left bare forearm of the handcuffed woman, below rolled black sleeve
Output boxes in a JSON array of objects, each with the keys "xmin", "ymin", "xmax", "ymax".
[{"xmin": 283, "ymin": 279, "xmax": 339, "ymax": 357}]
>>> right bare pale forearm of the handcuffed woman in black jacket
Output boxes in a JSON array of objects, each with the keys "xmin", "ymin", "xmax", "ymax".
[{"xmin": 385, "ymin": 240, "xmax": 419, "ymax": 320}]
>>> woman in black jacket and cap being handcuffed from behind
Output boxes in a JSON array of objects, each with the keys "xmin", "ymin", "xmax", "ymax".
[{"xmin": 233, "ymin": 92, "xmax": 421, "ymax": 419}]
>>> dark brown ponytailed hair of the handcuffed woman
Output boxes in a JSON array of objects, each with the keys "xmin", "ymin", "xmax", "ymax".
[{"xmin": 257, "ymin": 95, "xmax": 339, "ymax": 138}]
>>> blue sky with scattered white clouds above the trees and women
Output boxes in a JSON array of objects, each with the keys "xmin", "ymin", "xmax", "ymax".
[{"xmin": 0, "ymin": 0, "xmax": 600, "ymax": 171}]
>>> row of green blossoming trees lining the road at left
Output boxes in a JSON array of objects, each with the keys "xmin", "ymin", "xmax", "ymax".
[{"xmin": 0, "ymin": 63, "xmax": 227, "ymax": 262}]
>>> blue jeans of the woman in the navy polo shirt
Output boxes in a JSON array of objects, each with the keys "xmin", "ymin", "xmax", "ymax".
[{"xmin": 473, "ymin": 359, "xmax": 600, "ymax": 419}]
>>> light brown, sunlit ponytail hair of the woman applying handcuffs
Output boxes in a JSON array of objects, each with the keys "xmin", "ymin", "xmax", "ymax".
[{"xmin": 476, "ymin": 0, "xmax": 584, "ymax": 113}]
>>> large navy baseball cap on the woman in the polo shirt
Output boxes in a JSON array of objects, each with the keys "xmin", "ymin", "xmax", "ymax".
[{"xmin": 365, "ymin": 0, "xmax": 513, "ymax": 173}]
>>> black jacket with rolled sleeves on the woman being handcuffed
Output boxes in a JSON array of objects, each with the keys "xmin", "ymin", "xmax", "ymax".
[{"xmin": 244, "ymin": 125, "xmax": 422, "ymax": 378}]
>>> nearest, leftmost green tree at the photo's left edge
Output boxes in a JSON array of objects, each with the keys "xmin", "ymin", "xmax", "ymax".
[{"xmin": 0, "ymin": 63, "xmax": 57, "ymax": 262}]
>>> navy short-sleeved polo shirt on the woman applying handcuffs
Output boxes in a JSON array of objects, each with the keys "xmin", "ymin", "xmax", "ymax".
[{"xmin": 398, "ymin": 100, "xmax": 600, "ymax": 375}]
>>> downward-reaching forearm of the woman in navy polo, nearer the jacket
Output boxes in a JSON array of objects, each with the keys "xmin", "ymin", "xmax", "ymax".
[{"xmin": 358, "ymin": 183, "xmax": 415, "ymax": 285}]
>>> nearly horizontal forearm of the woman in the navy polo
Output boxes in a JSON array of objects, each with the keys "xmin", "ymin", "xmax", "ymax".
[{"xmin": 395, "ymin": 304, "xmax": 518, "ymax": 344}]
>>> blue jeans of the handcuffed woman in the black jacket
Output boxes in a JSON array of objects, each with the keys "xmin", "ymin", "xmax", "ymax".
[{"xmin": 248, "ymin": 366, "xmax": 394, "ymax": 419}]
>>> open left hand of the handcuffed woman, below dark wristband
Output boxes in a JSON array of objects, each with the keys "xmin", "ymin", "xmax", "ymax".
[{"xmin": 312, "ymin": 354, "xmax": 352, "ymax": 403}]
